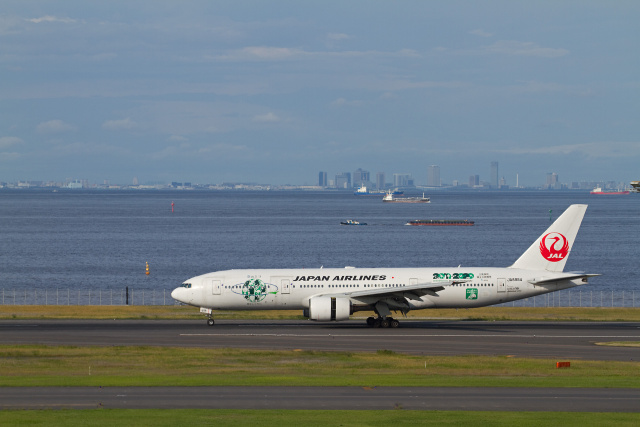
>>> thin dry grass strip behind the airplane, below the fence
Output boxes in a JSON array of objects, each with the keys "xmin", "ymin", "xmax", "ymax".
[{"xmin": 0, "ymin": 305, "xmax": 640, "ymax": 322}]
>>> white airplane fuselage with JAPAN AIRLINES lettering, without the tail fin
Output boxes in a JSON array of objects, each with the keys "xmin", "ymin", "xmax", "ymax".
[{"xmin": 171, "ymin": 267, "xmax": 586, "ymax": 311}]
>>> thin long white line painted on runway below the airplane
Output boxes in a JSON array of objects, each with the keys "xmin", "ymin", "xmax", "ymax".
[{"xmin": 180, "ymin": 334, "xmax": 640, "ymax": 338}]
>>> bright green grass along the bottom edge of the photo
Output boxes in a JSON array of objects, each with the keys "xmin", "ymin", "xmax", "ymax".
[{"xmin": 0, "ymin": 409, "xmax": 640, "ymax": 427}]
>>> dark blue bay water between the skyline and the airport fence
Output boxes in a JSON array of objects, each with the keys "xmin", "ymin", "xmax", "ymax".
[{"xmin": 0, "ymin": 191, "xmax": 640, "ymax": 299}]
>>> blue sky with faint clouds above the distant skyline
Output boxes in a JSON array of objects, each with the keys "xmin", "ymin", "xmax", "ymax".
[{"xmin": 0, "ymin": 0, "xmax": 640, "ymax": 186}]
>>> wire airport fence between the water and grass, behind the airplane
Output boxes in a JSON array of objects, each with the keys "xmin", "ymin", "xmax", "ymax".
[{"xmin": 1, "ymin": 288, "xmax": 640, "ymax": 307}]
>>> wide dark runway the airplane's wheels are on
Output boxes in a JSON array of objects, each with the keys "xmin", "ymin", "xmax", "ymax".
[{"xmin": 0, "ymin": 319, "xmax": 640, "ymax": 361}]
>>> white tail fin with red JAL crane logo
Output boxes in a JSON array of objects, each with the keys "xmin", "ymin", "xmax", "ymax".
[{"xmin": 511, "ymin": 205, "xmax": 587, "ymax": 272}]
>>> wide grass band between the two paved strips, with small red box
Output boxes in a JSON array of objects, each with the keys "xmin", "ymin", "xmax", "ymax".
[{"xmin": 0, "ymin": 345, "xmax": 640, "ymax": 388}]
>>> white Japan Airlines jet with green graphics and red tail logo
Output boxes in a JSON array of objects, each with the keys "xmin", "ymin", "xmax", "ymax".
[{"xmin": 171, "ymin": 205, "xmax": 599, "ymax": 328}]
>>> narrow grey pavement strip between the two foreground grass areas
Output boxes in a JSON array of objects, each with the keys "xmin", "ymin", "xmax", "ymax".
[{"xmin": 0, "ymin": 387, "xmax": 640, "ymax": 412}]
